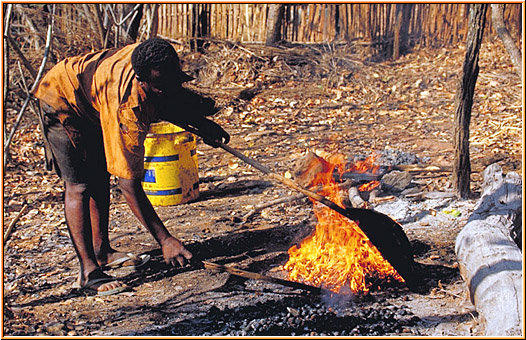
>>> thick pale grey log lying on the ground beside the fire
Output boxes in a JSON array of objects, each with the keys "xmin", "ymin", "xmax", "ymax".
[{"xmin": 455, "ymin": 164, "xmax": 524, "ymax": 337}]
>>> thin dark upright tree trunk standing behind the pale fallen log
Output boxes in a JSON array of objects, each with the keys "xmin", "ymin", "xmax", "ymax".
[{"xmin": 452, "ymin": 4, "xmax": 488, "ymax": 199}]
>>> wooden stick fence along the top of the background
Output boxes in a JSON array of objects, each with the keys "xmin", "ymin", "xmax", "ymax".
[{"xmin": 159, "ymin": 3, "xmax": 522, "ymax": 46}]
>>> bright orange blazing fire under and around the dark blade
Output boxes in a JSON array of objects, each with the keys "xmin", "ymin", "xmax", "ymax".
[{"xmin": 284, "ymin": 155, "xmax": 403, "ymax": 293}]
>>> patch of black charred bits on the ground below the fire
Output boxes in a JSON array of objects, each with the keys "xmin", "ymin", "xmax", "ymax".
[{"xmin": 137, "ymin": 296, "xmax": 420, "ymax": 336}]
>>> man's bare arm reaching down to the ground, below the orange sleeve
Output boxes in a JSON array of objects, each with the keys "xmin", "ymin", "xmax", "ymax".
[{"xmin": 119, "ymin": 178, "xmax": 192, "ymax": 266}]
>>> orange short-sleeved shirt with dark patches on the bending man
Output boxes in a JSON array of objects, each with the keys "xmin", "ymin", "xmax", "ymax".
[{"xmin": 34, "ymin": 43, "xmax": 155, "ymax": 179}]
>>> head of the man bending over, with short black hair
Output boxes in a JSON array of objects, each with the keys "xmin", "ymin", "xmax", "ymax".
[{"xmin": 131, "ymin": 38, "xmax": 193, "ymax": 94}]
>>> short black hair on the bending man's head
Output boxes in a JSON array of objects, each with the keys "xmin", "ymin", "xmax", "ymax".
[{"xmin": 131, "ymin": 38, "xmax": 181, "ymax": 81}]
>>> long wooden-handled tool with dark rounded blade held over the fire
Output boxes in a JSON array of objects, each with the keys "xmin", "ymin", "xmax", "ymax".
[{"xmin": 217, "ymin": 142, "xmax": 422, "ymax": 291}]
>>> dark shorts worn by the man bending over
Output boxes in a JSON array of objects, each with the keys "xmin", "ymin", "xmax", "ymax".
[{"xmin": 40, "ymin": 102, "xmax": 109, "ymax": 184}]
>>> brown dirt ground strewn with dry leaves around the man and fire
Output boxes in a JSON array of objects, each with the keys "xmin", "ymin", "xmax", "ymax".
[{"xmin": 3, "ymin": 40, "xmax": 523, "ymax": 336}]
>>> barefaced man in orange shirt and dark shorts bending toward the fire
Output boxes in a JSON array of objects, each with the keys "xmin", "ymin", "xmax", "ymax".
[{"xmin": 34, "ymin": 38, "xmax": 230, "ymax": 295}]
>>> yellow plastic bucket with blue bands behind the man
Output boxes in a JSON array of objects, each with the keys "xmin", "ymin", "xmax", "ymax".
[{"xmin": 142, "ymin": 122, "xmax": 199, "ymax": 206}]
